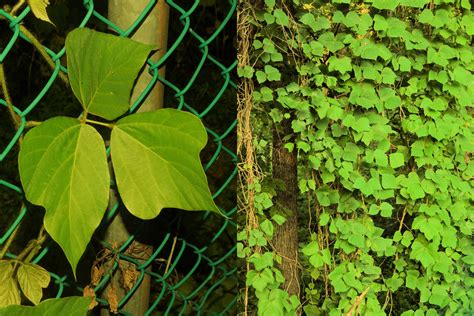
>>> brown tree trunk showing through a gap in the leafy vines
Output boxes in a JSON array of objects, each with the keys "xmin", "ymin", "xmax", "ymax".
[{"xmin": 272, "ymin": 120, "xmax": 300, "ymax": 297}]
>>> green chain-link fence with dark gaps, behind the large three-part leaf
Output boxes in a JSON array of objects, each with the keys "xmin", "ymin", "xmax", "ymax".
[{"xmin": 0, "ymin": 0, "xmax": 237, "ymax": 315}]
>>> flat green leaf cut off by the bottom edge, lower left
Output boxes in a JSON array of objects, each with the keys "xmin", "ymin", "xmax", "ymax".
[{"xmin": 0, "ymin": 296, "xmax": 91, "ymax": 316}]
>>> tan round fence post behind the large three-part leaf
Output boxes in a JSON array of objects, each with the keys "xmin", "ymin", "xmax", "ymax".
[{"xmin": 101, "ymin": 0, "xmax": 169, "ymax": 316}]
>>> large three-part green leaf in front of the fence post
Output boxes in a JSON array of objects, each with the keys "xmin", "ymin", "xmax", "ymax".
[{"xmin": 17, "ymin": 29, "xmax": 219, "ymax": 278}]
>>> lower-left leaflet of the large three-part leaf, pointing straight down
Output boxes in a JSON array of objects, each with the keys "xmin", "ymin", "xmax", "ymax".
[{"xmin": 19, "ymin": 117, "xmax": 110, "ymax": 273}]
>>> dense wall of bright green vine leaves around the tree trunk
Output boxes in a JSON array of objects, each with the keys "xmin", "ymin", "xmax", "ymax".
[{"xmin": 239, "ymin": 0, "xmax": 474, "ymax": 315}]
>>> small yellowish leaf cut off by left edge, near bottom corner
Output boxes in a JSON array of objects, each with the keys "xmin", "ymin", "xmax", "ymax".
[{"xmin": 0, "ymin": 260, "xmax": 21, "ymax": 308}]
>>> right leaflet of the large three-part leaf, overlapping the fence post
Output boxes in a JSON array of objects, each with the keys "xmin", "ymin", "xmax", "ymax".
[{"xmin": 111, "ymin": 109, "xmax": 219, "ymax": 219}]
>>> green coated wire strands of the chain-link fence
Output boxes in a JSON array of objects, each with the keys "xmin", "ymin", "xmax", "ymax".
[{"xmin": 0, "ymin": 0, "xmax": 237, "ymax": 315}]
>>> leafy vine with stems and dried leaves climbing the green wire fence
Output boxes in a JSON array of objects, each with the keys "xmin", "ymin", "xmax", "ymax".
[{"xmin": 0, "ymin": 0, "xmax": 220, "ymax": 315}]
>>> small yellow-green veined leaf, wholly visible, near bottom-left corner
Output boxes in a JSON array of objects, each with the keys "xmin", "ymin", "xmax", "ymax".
[{"xmin": 16, "ymin": 264, "xmax": 51, "ymax": 305}]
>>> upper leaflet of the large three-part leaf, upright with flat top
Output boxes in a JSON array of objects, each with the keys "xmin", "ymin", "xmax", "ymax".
[{"xmin": 66, "ymin": 28, "xmax": 153, "ymax": 120}]
